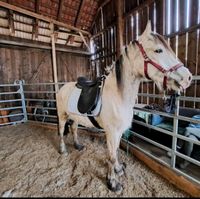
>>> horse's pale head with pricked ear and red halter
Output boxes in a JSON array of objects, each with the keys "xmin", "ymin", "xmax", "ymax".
[{"xmin": 131, "ymin": 21, "xmax": 192, "ymax": 91}]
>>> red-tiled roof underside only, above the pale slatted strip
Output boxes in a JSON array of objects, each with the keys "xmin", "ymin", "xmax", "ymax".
[{"xmin": 4, "ymin": 0, "xmax": 99, "ymax": 30}]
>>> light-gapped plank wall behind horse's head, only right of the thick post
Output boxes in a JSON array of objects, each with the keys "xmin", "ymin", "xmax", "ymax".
[{"xmin": 125, "ymin": 0, "xmax": 200, "ymax": 108}]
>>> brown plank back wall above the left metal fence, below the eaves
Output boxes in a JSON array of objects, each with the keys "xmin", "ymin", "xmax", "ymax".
[{"xmin": 0, "ymin": 46, "xmax": 90, "ymax": 84}]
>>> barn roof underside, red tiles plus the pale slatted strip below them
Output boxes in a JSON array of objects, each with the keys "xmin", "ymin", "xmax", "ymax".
[{"xmin": 0, "ymin": 0, "xmax": 103, "ymax": 47}]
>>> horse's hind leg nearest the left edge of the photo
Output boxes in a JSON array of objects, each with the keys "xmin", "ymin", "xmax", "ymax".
[{"xmin": 58, "ymin": 114, "xmax": 67, "ymax": 155}]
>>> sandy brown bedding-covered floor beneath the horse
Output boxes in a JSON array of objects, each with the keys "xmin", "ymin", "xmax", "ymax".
[{"xmin": 0, "ymin": 124, "xmax": 191, "ymax": 197}]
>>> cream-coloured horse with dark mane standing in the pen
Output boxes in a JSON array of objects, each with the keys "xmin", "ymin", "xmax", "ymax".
[{"xmin": 57, "ymin": 21, "xmax": 192, "ymax": 191}]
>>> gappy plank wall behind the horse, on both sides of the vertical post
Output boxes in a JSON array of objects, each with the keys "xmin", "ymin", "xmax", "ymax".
[{"xmin": 93, "ymin": 0, "xmax": 200, "ymax": 108}]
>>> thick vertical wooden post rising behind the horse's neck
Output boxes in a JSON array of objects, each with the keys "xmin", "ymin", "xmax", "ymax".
[{"xmin": 116, "ymin": 0, "xmax": 124, "ymax": 57}]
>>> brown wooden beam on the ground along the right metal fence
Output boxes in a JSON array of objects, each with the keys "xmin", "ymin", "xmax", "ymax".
[{"xmin": 121, "ymin": 141, "xmax": 200, "ymax": 197}]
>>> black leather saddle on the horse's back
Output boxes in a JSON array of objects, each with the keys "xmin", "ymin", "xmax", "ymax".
[{"xmin": 76, "ymin": 77, "xmax": 102, "ymax": 113}]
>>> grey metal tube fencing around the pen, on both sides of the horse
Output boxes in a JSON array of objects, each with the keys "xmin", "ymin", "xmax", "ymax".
[{"xmin": 0, "ymin": 79, "xmax": 200, "ymax": 187}]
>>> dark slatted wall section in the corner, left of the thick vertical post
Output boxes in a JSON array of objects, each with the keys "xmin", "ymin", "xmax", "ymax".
[{"xmin": 92, "ymin": 0, "xmax": 117, "ymax": 75}]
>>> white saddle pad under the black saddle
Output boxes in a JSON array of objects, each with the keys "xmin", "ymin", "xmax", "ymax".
[{"xmin": 67, "ymin": 87, "xmax": 102, "ymax": 117}]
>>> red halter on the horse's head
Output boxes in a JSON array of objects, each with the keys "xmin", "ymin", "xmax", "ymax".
[{"xmin": 135, "ymin": 41, "xmax": 183, "ymax": 90}]
